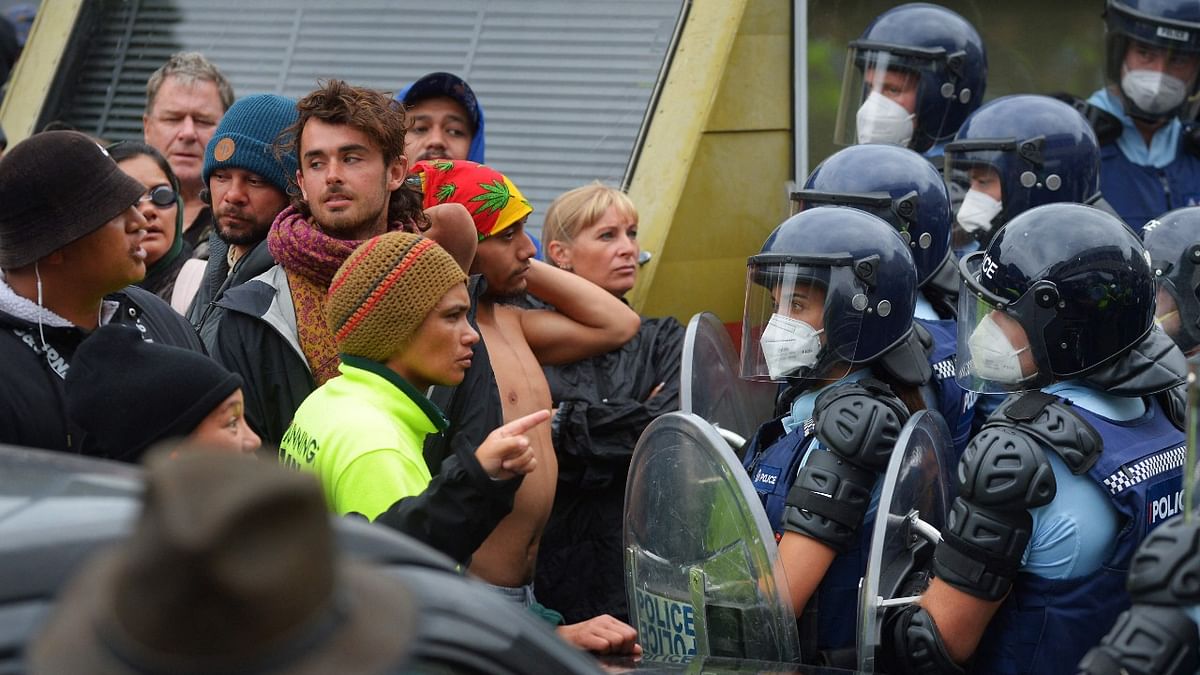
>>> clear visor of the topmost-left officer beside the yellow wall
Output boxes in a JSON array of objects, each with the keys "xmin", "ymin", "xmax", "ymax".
[{"xmin": 834, "ymin": 42, "xmax": 940, "ymax": 148}]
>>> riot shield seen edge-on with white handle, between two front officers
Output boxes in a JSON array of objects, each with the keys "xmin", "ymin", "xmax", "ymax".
[{"xmin": 858, "ymin": 411, "xmax": 956, "ymax": 673}]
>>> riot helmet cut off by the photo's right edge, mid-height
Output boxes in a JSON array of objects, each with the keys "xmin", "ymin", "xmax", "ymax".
[{"xmin": 1141, "ymin": 207, "xmax": 1200, "ymax": 353}]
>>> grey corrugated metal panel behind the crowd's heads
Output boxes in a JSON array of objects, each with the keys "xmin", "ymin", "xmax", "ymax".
[{"xmin": 59, "ymin": 0, "xmax": 684, "ymax": 229}]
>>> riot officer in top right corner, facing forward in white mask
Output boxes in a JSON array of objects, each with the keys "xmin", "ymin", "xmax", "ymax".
[{"xmin": 1087, "ymin": 0, "xmax": 1200, "ymax": 229}]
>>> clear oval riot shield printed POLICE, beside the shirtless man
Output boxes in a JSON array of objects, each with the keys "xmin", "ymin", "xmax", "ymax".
[{"xmin": 624, "ymin": 412, "xmax": 799, "ymax": 662}]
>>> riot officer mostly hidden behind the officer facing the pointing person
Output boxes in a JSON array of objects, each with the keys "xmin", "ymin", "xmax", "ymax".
[{"xmin": 792, "ymin": 145, "xmax": 974, "ymax": 452}]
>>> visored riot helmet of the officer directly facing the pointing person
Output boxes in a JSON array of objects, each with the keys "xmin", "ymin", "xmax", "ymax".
[{"xmin": 742, "ymin": 207, "xmax": 917, "ymax": 381}]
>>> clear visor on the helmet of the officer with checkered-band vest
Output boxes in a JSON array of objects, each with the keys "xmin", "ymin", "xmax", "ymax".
[{"xmin": 954, "ymin": 252, "xmax": 1052, "ymax": 394}]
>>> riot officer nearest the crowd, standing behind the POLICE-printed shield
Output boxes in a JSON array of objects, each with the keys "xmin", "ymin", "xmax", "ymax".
[{"xmin": 742, "ymin": 207, "xmax": 924, "ymax": 653}]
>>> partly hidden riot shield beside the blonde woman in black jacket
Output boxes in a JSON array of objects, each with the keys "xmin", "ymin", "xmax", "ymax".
[{"xmin": 679, "ymin": 312, "xmax": 776, "ymax": 447}]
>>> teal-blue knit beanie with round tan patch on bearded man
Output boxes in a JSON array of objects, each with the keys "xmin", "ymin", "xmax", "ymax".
[{"xmin": 200, "ymin": 94, "xmax": 299, "ymax": 195}]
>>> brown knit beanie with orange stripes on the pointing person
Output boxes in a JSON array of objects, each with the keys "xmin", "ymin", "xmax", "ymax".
[{"xmin": 325, "ymin": 232, "xmax": 467, "ymax": 363}]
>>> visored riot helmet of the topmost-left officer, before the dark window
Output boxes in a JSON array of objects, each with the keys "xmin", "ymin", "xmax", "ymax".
[{"xmin": 834, "ymin": 2, "xmax": 988, "ymax": 153}]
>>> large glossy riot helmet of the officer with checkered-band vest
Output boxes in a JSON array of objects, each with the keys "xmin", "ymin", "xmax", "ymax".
[{"xmin": 956, "ymin": 199, "xmax": 1154, "ymax": 392}]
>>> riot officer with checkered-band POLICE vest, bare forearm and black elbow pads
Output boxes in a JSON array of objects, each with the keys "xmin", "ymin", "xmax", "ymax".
[{"xmin": 889, "ymin": 204, "xmax": 1184, "ymax": 674}]
